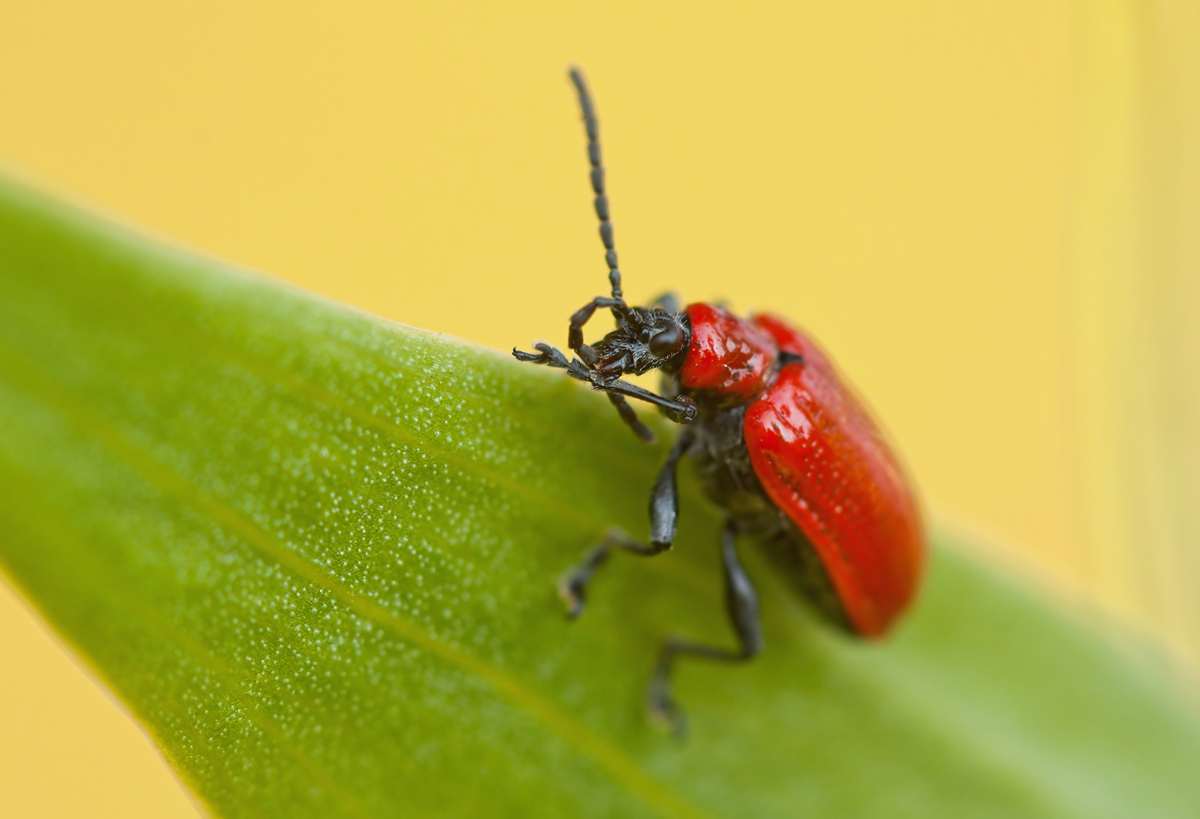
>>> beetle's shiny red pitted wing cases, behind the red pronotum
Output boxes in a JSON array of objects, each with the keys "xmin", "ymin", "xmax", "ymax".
[{"xmin": 743, "ymin": 316, "xmax": 925, "ymax": 638}]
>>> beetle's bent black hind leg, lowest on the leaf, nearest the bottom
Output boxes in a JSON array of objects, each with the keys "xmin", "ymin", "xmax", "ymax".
[{"xmin": 646, "ymin": 524, "xmax": 762, "ymax": 736}]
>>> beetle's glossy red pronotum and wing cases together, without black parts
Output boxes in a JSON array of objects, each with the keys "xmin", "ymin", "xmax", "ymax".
[{"xmin": 679, "ymin": 304, "xmax": 924, "ymax": 638}]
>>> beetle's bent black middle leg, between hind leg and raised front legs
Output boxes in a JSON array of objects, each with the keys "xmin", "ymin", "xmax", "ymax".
[{"xmin": 558, "ymin": 432, "xmax": 692, "ymax": 618}]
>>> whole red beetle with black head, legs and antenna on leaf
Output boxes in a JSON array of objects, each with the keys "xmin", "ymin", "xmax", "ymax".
[{"xmin": 512, "ymin": 68, "xmax": 925, "ymax": 733}]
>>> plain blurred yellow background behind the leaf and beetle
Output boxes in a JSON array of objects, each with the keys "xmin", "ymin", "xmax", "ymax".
[{"xmin": 0, "ymin": 0, "xmax": 1200, "ymax": 817}]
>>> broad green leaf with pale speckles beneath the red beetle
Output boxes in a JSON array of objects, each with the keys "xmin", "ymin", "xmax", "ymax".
[{"xmin": 0, "ymin": 176, "xmax": 1200, "ymax": 819}]
